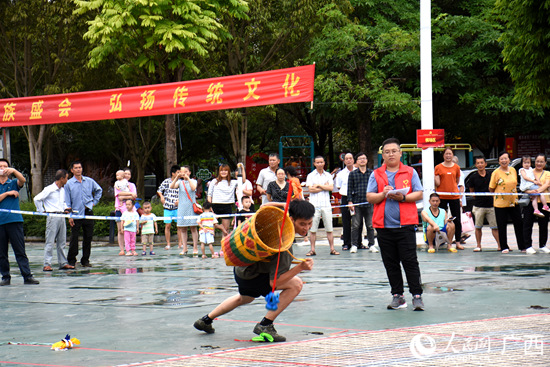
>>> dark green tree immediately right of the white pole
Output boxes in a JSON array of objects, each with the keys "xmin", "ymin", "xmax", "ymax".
[{"xmin": 432, "ymin": 0, "xmax": 543, "ymax": 152}]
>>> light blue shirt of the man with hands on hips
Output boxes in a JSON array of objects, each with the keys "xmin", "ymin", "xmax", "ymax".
[{"xmin": 65, "ymin": 176, "xmax": 103, "ymax": 215}]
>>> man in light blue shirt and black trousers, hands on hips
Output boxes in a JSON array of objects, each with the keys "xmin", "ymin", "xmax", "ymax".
[{"xmin": 65, "ymin": 161, "xmax": 103, "ymax": 268}]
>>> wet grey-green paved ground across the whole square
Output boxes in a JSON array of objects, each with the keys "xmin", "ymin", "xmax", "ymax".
[{"xmin": 0, "ymin": 229, "xmax": 550, "ymax": 366}]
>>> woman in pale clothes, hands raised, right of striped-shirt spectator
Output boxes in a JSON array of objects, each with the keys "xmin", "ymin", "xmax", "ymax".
[{"xmin": 170, "ymin": 166, "xmax": 199, "ymax": 255}]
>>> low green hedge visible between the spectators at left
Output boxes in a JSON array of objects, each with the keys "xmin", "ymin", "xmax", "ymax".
[{"xmin": 20, "ymin": 202, "xmax": 176, "ymax": 237}]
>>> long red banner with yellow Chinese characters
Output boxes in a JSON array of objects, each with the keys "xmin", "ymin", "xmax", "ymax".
[{"xmin": 0, "ymin": 65, "xmax": 315, "ymax": 127}]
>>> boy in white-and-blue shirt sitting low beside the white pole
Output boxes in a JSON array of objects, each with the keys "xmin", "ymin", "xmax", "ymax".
[{"xmin": 422, "ymin": 192, "xmax": 457, "ymax": 254}]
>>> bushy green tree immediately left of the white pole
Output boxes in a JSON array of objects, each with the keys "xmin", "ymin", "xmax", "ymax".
[{"xmin": 308, "ymin": 1, "xmax": 420, "ymax": 162}]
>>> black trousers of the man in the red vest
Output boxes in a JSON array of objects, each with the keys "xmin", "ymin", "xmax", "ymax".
[{"xmin": 376, "ymin": 226, "xmax": 422, "ymax": 295}]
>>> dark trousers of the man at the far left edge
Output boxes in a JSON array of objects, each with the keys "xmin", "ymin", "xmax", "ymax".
[{"xmin": 0, "ymin": 222, "xmax": 32, "ymax": 279}]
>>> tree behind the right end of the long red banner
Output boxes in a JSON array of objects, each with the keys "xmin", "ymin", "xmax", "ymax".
[{"xmin": 205, "ymin": 0, "xmax": 336, "ymax": 161}]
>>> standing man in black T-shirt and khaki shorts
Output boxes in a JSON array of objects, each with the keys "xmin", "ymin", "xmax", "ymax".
[{"xmin": 468, "ymin": 156, "xmax": 500, "ymax": 252}]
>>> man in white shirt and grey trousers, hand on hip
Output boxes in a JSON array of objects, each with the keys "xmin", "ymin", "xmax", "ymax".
[{"xmin": 34, "ymin": 169, "xmax": 74, "ymax": 271}]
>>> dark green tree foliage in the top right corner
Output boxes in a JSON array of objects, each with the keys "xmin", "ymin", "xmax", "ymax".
[{"xmin": 495, "ymin": 0, "xmax": 550, "ymax": 108}]
